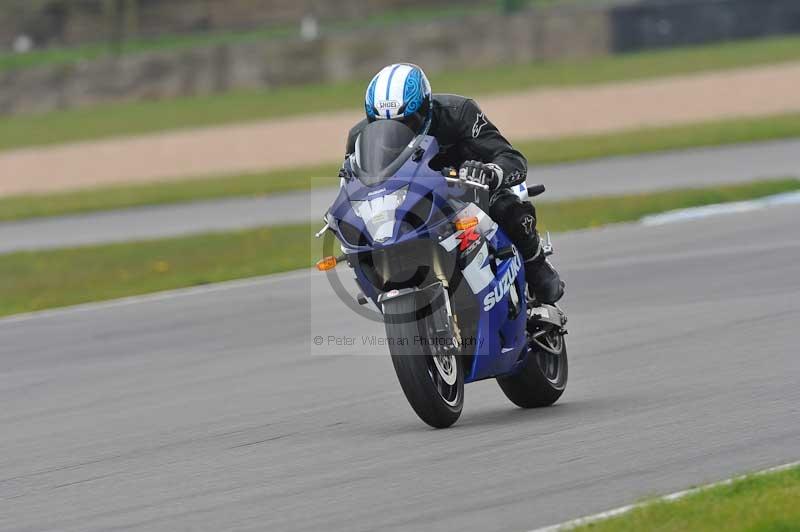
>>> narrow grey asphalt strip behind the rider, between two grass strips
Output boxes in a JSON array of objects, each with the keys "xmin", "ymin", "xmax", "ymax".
[{"xmin": 0, "ymin": 140, "xmax": 800, "ymax": 253}]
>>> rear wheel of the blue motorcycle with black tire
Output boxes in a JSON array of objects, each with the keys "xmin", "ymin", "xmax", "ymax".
[{"xmin": 497, "ymin": 330, "xmax": 568, "ymax": 408}]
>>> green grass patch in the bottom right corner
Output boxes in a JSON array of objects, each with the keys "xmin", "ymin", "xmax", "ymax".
[{"xmin": 574, "ymin": 467, "xmax": 800, "ymax": 532}]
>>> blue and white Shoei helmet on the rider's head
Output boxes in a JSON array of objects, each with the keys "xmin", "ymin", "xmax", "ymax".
[{"xmin": 365, "ymin": 63, "xmax": 431, "ymax": 133}]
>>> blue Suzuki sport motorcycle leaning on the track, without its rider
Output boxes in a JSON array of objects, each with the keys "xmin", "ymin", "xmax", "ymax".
[{"xmin": 317, "ymin": 120, "xmax": 567, "ymax": 428}]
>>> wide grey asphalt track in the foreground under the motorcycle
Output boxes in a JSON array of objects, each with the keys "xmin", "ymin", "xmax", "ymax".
[{"xmin": 0, "ymin": 206, "xmax": 800, "ymax": 532}]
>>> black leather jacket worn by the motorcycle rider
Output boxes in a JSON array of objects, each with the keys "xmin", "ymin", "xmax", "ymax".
[{"xmin": 346, "ymin": 94, "xmax": 528, "ymax": 188}]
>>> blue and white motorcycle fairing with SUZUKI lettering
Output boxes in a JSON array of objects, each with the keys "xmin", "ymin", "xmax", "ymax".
[{"xmin": 326, "ymin": 132, "xmax": 528, "ymax": 382}]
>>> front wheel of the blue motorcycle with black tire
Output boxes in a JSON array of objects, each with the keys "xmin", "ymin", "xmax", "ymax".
[{"xmin": 384, "ymin": 294, "xmax": 464, "ymax": 428}]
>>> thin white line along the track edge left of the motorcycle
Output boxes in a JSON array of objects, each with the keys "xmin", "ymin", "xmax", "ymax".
[{"xmin": 0, "ymin": 269, "xmax": 316, "ymax": 326}]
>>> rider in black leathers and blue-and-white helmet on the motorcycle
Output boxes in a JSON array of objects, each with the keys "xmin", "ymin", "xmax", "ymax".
[{"xmin": 346, "ymin": 63, "xmax": 564, "ymax": 303}]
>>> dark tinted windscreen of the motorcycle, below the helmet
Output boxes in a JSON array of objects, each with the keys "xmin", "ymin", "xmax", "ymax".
[{"xmin": 356, "ymin": 120, "xmax": 416, "ymax": 186}]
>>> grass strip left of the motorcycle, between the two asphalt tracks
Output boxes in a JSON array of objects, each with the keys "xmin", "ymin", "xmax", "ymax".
[{"xmin": 0, "ymin": 224, "xmax": 319, "ymax": 315}]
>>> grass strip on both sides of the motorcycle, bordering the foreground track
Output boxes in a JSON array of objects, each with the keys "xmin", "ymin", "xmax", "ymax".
[{"xmin": 0, "ymin": 179, "xmax": 800, "ymax": 315}]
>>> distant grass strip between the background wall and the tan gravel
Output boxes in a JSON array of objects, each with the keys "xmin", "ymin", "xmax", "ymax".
[{"xmin": 0, "ymin": 37, "xmax": 800, "ymax": 150}]
